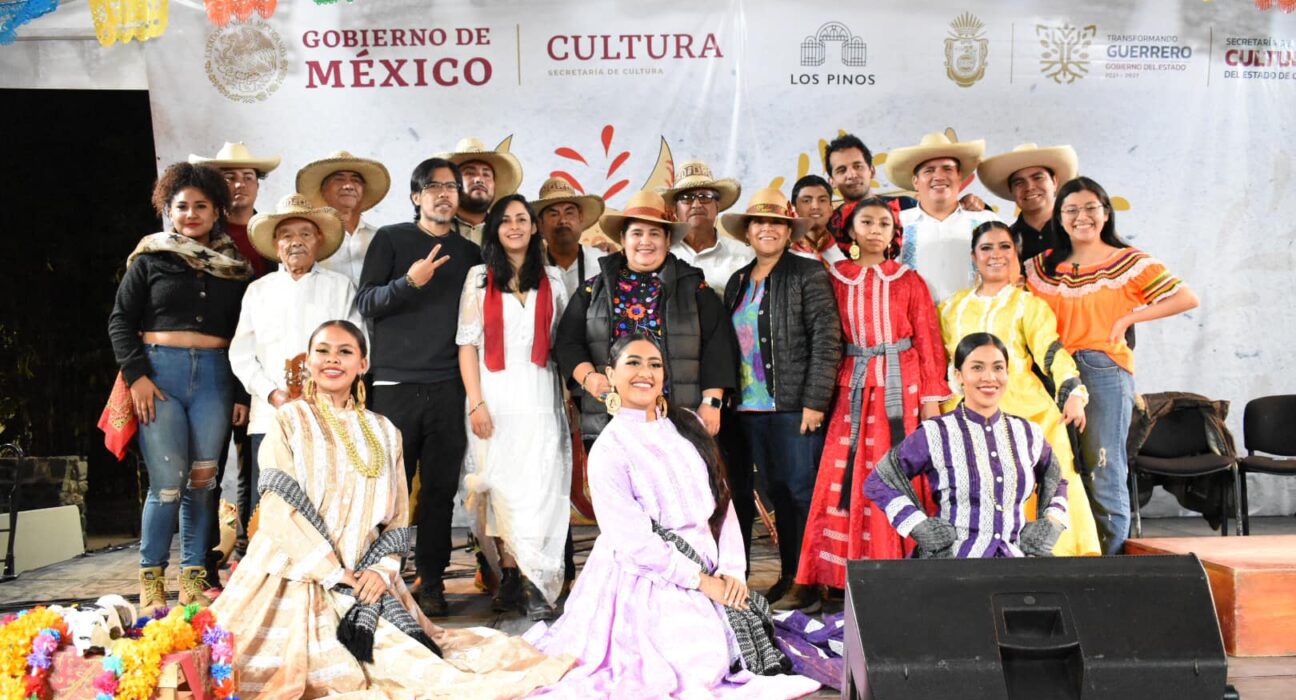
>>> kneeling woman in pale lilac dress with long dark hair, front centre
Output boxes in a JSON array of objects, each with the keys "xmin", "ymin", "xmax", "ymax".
[{"xmin": 526, "ymin": 332, "xmax": 818, "ymax": 697}]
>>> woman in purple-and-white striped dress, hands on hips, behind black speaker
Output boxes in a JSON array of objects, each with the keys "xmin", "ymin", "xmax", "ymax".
[{"xmin": 864, "ymin": 333, "xmax": 1069, "ymax": 559}]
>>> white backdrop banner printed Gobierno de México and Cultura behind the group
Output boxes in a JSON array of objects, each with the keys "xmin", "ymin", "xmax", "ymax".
[{"xmin": 134, "ymin": 0, "xmax": 1296, "ymax": 513}]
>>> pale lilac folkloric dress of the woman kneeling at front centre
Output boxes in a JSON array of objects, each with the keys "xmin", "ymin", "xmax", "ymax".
[{"xmin": 526, "ymin": 408, "xmax": 819, "ymax": 697}]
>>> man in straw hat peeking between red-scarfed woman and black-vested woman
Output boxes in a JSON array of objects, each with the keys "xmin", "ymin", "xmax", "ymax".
[{"xmin": 531, "ymin": 178, "xmax": 607, "ymax": 298}]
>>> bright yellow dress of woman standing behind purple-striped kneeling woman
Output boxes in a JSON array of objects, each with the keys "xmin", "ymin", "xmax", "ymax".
[{"xmin": 940, "ymin": 285, "xmax": 1102, "ymax": 556}]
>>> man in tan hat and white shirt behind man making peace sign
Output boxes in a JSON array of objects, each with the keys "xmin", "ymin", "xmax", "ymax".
[{"xmin": 297, "ymin": 150, "xmax": 391, "ymax": 286}]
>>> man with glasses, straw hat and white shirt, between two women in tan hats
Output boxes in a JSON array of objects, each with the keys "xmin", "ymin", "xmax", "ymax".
[{"xmin": 661, "ymin": 161, "xmax": 756, "ymax": 297}]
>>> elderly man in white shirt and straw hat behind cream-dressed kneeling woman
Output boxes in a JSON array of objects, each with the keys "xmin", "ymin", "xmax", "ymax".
[{"xmin": 229, "ymin": 193, "xmax": 363, "ymax": 528}]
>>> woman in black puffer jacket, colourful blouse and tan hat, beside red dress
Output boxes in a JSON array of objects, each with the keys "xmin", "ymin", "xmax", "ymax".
[{"xmin": 721, "ymin": 188, "xmax": 841, "ymax": 601}]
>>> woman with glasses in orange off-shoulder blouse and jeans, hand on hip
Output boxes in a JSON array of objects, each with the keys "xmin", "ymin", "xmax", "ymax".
[{"xmin": 1026, "ymin": 178, "xmax": 1200, "ymax": 554}]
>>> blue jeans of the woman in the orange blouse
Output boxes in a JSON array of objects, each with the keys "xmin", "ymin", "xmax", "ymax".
[{"xmin": 1074, "ymin": 350, "xmax": 1134, "ymax": 555}]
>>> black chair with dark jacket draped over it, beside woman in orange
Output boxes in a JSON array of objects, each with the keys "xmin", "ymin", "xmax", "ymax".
[{"xmin": 1129, "ymin": 407, "xmax": 1244, "ymax": 537}]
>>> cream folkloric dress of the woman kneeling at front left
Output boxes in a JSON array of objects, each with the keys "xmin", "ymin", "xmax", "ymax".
[{"xmin": 211, "ymin": 401, "xmax": 575, "ymax": 700}]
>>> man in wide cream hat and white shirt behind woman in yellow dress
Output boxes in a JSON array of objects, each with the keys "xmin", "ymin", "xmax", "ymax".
[{"xmin": 886, "ymin": 132, "xmax": 998, "ymax": 303}]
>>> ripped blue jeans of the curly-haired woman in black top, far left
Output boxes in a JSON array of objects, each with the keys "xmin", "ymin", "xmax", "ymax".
[{"xmin": 140, "ymin": 345, "xmax": 235, "ymax": 568}]
